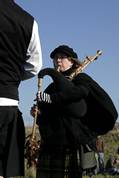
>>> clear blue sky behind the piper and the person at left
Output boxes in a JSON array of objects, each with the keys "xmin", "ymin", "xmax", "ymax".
[{"xmin": 16, "ymin": 0, "xmax": 119, "ymax": 125}]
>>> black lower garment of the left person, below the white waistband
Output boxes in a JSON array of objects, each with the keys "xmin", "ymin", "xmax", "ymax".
[{"xmin": 0, "ymin": 106, "xmax": 25, "ymax": 177}]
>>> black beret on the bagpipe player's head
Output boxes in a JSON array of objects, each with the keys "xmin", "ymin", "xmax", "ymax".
[{"xmin": 50, "ymin": 45, "xmax": 78, "ymax": 59}]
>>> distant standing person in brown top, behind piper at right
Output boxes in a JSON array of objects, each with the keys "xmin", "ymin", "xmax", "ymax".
[{"xmin": 96, "ymin": 136, "xmax": 105, "ymax": 173}]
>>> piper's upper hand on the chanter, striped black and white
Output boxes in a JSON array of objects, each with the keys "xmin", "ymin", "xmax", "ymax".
[{"xmin": 37, "ymin": 92, "xmax": 52, "ymax": 103}]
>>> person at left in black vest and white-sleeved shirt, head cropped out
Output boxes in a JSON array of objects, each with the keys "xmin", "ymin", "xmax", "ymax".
[{"xmin": 0, "ymin": 0, "xmax": 42, "ymax": 178}]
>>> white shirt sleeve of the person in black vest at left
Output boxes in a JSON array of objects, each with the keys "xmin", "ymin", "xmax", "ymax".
[{"xmin": 22, "ymin": 20, "xmax": 42, "ymax": 80}]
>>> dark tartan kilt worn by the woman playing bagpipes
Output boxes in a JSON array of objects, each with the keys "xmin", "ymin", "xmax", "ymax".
[{"xmin": 36, "ymin": 147, "xmax": 82, "ymax": 178}]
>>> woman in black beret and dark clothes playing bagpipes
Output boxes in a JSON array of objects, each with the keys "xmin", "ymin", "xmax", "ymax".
[{"xmin": 31, "ymin": 45, "xmax": 117, "ymax": 178}]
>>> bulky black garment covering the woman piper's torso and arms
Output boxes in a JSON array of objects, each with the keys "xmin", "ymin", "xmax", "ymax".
[{"xmin": 38, "ymin": 69, "xmax": 117, "ymax": 145}]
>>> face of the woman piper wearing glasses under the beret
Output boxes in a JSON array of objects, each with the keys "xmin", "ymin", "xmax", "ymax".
[{"xmin": 53, "ymin": 53, "xmax": 73, "ymax": 72}]
